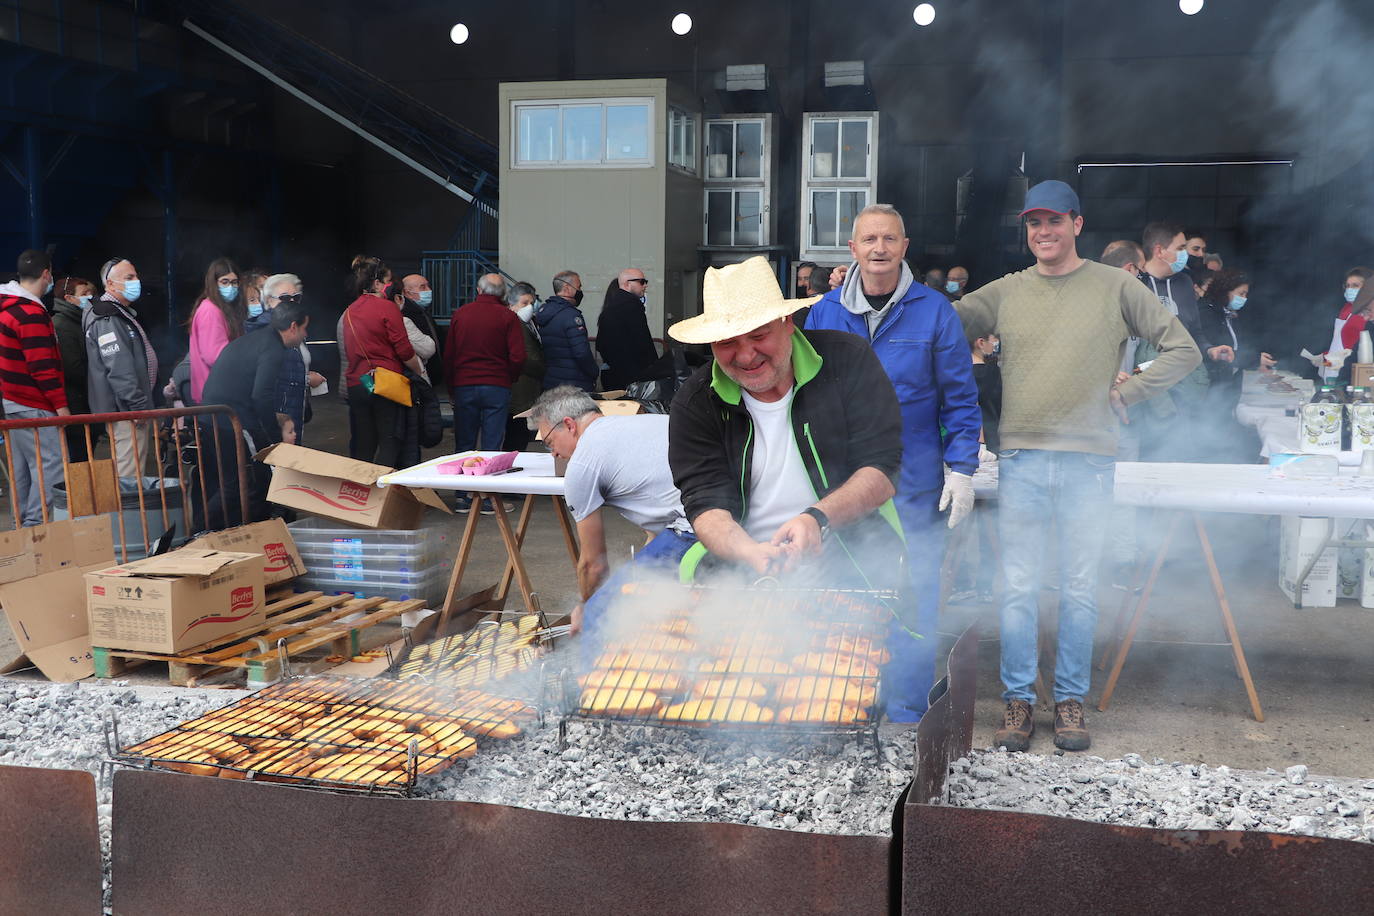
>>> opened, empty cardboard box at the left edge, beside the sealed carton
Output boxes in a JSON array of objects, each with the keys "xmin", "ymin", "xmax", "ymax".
[{"xmin": 0, "ymin": 516, "xmax": 114, "ymax": 681}]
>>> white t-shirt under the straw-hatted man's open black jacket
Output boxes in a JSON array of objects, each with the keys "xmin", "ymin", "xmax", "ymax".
[{"xmin": 742, "ymin": 391, "xmax": 816, "ymax": 542}]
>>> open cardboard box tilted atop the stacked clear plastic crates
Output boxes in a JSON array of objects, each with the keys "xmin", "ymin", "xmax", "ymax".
[{"xmin": 256, "ymin": 442, "xmax": 451, "ymax": 530}]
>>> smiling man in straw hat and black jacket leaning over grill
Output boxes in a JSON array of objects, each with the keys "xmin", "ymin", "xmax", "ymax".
[{"xmin": 668, "ymin": 257, "xmax": 917, "ymax": 714}]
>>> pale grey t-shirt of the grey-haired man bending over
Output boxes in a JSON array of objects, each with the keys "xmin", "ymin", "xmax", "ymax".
[{"xmin": 563, "ymin": 413, "xmax": 691, "ymax": 534}]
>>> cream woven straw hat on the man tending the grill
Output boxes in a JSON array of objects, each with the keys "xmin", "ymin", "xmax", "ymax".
[{"xmin": 668, "ymin": 255, "xmax": 820, "ymax": 343}]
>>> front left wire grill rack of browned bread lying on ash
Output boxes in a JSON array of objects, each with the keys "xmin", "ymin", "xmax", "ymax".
[{"xmin": 107, "ymin": 676, "xmax": 539, "ymax": 795}]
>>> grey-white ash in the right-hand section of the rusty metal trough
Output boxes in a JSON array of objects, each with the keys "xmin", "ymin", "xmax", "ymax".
[{"xmin": 948, "ymin": 750, "xmax": 1374, "ymax": 842}]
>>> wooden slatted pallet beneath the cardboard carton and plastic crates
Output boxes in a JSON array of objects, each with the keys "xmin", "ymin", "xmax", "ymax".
[{"xmin": 92, "ymin": 592, "xmax": 425, "ymax": 687}]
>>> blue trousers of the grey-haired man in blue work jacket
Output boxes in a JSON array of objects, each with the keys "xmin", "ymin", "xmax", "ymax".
[{"xmin": 882, "ymin": 490, "xmax": 948, "ymax": 722}]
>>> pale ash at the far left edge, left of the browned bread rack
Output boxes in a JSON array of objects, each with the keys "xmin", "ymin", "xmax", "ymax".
[{"xmin": 0, "ymin": 678, "xmax": 243, "ymax": 911}]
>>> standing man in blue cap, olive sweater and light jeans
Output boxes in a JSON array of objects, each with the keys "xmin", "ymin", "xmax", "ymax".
[{"xmin": 955, "ymin": 181, "xmax": 1202, "ymax": 751}]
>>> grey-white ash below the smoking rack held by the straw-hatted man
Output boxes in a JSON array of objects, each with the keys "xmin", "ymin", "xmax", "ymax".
[{"xmin": 419, "ymin": 720, "xmax": 915, "ymax": 836}]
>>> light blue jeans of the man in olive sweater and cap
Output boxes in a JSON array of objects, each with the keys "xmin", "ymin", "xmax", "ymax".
[{"xmin": 998, "ymin": 449, "xmax": 1116, "ymax": 703}]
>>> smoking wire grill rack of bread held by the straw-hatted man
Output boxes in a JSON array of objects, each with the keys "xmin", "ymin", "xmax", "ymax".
[{"xmin": 563, "ymin": 588, "xmax": 897, "ymax": 747}]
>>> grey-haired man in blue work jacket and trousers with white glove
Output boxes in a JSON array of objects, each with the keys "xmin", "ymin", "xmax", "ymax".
[{"xmin": 807, "ymin": 203, "xmax": 982, "ymax": 721}]
